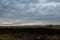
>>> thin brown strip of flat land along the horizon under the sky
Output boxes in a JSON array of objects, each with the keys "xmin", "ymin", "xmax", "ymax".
[{"xmin": 0, "ymin": 25, "xmax": 60, "ymax": 29}]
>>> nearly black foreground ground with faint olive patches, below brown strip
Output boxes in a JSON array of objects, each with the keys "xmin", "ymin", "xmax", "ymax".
[{"xmin": 0, "ymin": 28, "xmax": 60, "ymax": 40}]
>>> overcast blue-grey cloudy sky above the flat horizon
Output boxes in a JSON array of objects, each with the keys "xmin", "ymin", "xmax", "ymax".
[{"xmin": 0, "ymin": 0, "xmax": 60, "ymax": 24}]
